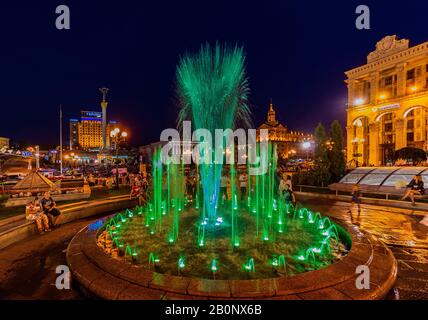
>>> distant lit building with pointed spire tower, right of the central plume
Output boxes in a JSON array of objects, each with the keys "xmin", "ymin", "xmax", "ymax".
[{"xmin": 257, "ymin": 102, "xmax": 313, "ymax": 159}]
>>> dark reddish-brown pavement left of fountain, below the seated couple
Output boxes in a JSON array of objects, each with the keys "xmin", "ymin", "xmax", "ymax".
[{"xmin": 0, "ymin": 217, "xmax": 99, "ymax": 300}]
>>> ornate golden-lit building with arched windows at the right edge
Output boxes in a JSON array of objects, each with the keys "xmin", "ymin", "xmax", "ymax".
[{"xmin": 345, "ymin": 35, "xmax": 428, "ymax": 166}]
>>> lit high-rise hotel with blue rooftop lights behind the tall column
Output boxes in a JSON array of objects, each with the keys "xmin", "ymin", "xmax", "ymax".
[{"xmin": 70, "ymin": 111, "xmax": 118, "ymax": 150}]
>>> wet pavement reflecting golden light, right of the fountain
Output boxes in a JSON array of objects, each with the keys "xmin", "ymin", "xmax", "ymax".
[{"xmin": 304, "ymin": 200, "xmax": 428, "ymax": 300}]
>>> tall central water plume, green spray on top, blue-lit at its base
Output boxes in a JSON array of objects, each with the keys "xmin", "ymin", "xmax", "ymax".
[{"xmin": 177, "ymin": 44, "xmax": 250, "ymax": 221}]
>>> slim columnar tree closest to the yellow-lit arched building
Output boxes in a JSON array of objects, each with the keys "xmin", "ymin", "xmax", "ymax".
[{"xmin": 329, "ymin": 120, "xmax": 346, "ymax": 182}]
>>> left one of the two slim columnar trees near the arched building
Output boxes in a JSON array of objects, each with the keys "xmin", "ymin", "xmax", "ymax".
[{"xmin": 313, "ymin": 123, "xmax": 331, "ymax": 186}]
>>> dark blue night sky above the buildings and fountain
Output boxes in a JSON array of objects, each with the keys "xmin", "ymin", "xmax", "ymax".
[{"xmin": 0, "ymin": 0, "xmax": 428, "ymax": 144}]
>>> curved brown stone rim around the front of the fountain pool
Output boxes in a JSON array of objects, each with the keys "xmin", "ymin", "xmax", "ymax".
[{"xmin": 67, "ymin": 218, "xmax": 397, "ymax": 300}]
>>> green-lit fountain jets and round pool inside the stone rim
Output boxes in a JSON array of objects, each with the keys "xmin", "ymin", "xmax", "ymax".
[{"xmin": 98, "ymin": 45, "xmax": 349, "ymax": 279}]
